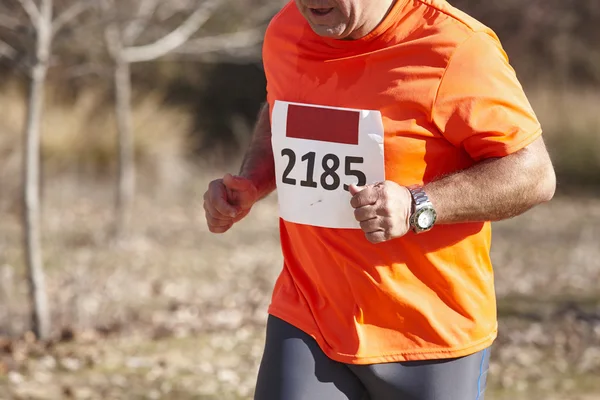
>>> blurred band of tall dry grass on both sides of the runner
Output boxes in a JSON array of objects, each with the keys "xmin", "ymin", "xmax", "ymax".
[{"xmin": 0, "ymin": 85, "xmax": 600, "ymax": 190}]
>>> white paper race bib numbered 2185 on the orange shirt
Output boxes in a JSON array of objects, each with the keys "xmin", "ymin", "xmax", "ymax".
[{"xmin": 271, "ymin": 101, "xmax": 385, "ymax": 229}]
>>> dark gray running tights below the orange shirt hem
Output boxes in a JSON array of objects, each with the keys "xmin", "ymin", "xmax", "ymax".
[{"xmin": 254, "ymin": 316, "xmax": 490, "ymax": 400}]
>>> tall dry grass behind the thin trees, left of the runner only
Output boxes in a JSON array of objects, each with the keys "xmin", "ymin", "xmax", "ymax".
[{"xmin": 0, "ymin": 86, "xmax": 192, "ymax": 197}]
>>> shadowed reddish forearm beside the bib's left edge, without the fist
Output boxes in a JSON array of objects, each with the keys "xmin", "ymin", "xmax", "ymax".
[{"xmin": 239, "ymin": 104, "xmax": 276, "ymax": 199}]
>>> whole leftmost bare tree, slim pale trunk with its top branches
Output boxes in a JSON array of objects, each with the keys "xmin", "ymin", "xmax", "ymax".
[{"xmin": 0, "ymin": 0, "xmax": 85, "ymax": 339}]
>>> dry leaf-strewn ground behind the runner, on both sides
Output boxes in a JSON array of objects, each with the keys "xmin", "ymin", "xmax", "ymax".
[{"xmin": 0, "ymin": 178, "xmax": 600, "ymax": 400}]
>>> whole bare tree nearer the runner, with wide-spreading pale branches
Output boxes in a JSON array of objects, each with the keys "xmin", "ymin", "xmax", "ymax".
[{"xmin": 102, "ymin": 0, "xmax": 264, "ymax": 237}]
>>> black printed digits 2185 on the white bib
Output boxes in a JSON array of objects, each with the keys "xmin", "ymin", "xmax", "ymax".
[{"xmin": 281, "ymin": 148, "xmax": 367, "ymax": 191}]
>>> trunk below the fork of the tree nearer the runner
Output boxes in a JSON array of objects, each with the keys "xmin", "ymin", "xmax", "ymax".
[{"xmin": 114, "ymin": 57, "xmax": 135, "ymax": 237}]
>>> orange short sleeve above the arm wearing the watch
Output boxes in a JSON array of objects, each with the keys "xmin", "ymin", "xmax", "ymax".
[{"xmin": 432, "ymin": 33, "xmax": 542, "ymax": 160}]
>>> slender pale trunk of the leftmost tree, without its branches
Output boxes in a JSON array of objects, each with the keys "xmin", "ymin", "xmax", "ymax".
[{"xmin": 23, "ymin": 0, "xmax": 52, "ymax": 340}]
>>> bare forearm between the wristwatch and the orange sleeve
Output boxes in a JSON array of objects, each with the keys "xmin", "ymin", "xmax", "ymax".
[{"xmin": 425, "ymin": 140, "xmax": 556, "ymax": 224}]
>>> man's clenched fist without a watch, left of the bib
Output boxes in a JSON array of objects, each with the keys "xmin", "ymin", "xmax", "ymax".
[{"xmin": 204, "ymin": 174, "xmax": 258, "ymax": 233}]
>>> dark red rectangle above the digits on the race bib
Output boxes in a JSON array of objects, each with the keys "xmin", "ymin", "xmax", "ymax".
[{"xmin": 286, "ymin": 104, "xmax": 360, "ymax": 144}]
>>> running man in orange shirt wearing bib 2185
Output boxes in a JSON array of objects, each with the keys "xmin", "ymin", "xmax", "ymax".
[{"xmin": 204, "ymin": 0, "xmax": 555, "ymax": 400}]
